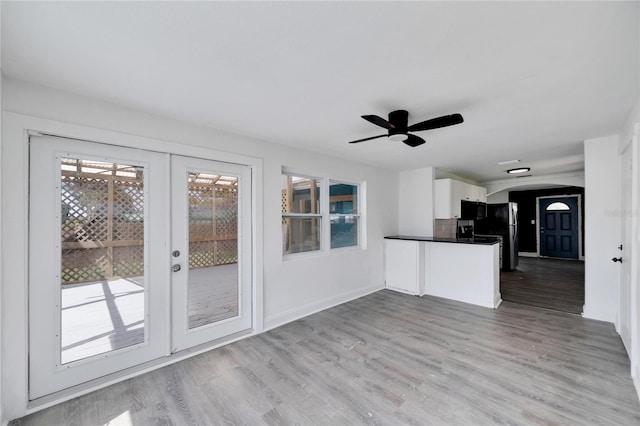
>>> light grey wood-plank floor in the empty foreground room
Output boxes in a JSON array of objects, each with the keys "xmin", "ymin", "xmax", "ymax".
[{"xmin": 12, "ymin": 290, "xmax": 640, "ymax": 426}]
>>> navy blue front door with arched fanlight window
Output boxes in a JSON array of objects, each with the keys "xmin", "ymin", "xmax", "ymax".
[{"xmin": 540, "ymin": 197, "xmax": 579, "ymax": 259}]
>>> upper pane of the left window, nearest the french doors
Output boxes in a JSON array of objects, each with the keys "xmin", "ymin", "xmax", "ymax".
[{"xmin": 282, "ymin": 175, "xmax": 320, "ymax": 214}]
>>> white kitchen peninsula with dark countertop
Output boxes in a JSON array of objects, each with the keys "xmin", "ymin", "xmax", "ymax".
[{"xmin": 385, "ymin": 235, "xmax": 502, "ymax": 308}]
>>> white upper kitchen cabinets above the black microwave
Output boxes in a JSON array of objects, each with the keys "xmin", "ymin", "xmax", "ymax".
[{"xmin": 434, "ymin": 179, "xmax": 487, "ymax": 219}]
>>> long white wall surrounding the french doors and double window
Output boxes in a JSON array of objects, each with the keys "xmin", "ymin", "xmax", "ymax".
[{"xmin": 0, "ymin": 80, "xmax": 400, "ymax": 421}]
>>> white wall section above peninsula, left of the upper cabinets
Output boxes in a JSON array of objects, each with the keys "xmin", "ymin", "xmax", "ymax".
[{"xmin": 398, "ymin": 167, "xmax": 435, "ymax": 237}]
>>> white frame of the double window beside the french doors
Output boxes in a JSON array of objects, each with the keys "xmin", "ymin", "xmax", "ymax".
[{"xmin": 281, "ymin": 171, "xmax": 365, "ymax": 259}]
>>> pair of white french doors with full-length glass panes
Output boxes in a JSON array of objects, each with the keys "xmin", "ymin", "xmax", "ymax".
[{"xmin": 29, "ymin": 136, "xmax": 252, "ymax": 399}]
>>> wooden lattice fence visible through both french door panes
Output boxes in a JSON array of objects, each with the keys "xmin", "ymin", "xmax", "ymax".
[{"xmin": 61, "ymin": 159, "xmax": 238, "ymax": 284}]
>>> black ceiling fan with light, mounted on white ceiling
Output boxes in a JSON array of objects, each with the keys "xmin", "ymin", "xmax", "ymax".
[{"xmin": 349, "ymin": 109, "xmax": 464, "ymax": 147}]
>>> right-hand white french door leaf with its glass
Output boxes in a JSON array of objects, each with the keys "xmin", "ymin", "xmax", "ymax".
[{"xmin": 171, "ymin": 155, "xmax": 252, "ymax": 352}]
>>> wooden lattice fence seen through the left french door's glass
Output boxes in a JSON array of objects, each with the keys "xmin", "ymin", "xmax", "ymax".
[{"xmin": 61, "ymin": 165, "xmax": 144, "ymax": 284}]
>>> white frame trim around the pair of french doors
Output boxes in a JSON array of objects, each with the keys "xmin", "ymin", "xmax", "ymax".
[{"xmin": 0, "ymin": 111, "xmax": 264, "ymax": 418}]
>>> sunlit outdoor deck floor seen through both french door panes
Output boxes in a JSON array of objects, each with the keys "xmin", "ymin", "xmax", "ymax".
[{"xmin": 61, "ymin": 264, "xmax": 238, "ymax": 364}]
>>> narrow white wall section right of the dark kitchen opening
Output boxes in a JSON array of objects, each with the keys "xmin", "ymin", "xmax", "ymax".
[{"xmin": 583, "ymin": 135, "xmax": 620, "ymax": 322}]
